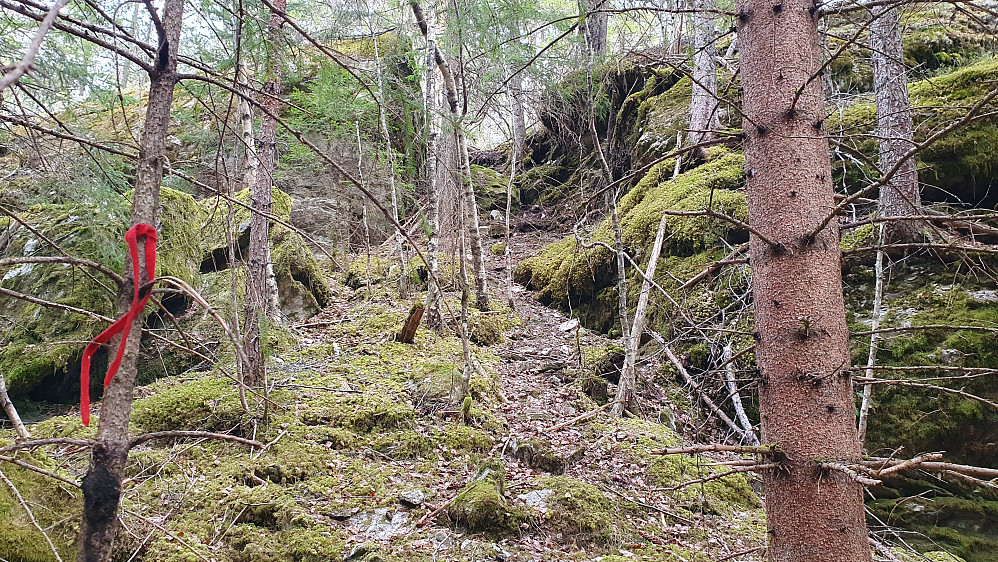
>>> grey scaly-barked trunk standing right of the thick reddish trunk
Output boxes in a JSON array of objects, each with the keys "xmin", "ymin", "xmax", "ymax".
[{"xmin": 870, "ymin": 6, "xmax": 924, "ymax": 243}]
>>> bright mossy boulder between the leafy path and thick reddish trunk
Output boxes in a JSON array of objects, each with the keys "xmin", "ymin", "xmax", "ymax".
[{"xmin": 514, "ymin": 148, "xmax": 748, "ymax": 331}]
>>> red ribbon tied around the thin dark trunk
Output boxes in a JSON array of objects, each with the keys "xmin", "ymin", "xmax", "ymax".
[{"xmin": 80, "ymin": 223, "xmax": 156, "ymax": 426}]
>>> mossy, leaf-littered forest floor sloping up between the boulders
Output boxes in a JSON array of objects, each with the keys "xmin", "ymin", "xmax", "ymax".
[{"xmin": 0, "ymin": 208, "xmax": 765, "ymax": 562}]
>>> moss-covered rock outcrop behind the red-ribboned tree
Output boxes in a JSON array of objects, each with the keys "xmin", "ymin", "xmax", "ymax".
[{"xmin": 0, "ymin": 182, "xmax": 329, "ymax": 400}]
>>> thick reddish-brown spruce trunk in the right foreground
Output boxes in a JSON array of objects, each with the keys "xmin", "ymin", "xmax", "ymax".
[{"xmin": 737, "ymin": 0, "xmax": 871, "ymax": 562}]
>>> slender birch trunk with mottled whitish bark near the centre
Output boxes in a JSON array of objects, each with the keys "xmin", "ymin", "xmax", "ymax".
[{"xmin": 423, "ymin": 4, "xmax": 441, "ymax": 329}]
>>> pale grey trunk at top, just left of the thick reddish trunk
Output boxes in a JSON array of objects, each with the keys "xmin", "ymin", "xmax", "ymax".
[{"xmin": 687, "ymin": 0, "xmax": 721, "ymax": 151}]
